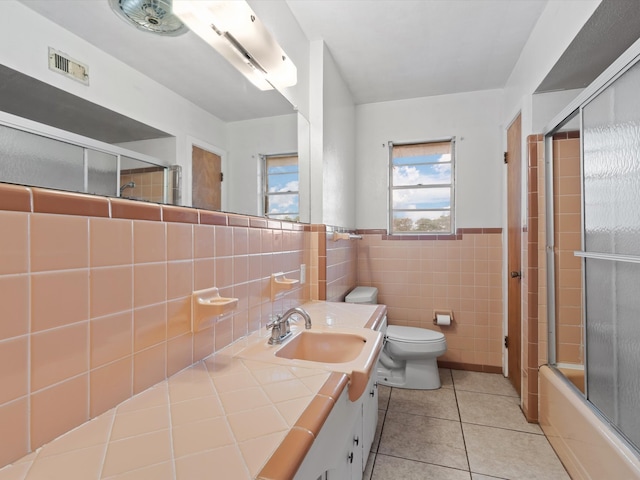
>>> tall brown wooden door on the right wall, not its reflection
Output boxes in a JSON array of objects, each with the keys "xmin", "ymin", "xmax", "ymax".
[{"xmin": 507, "ymin": 115, "xmax": 522, "ymax": 395}]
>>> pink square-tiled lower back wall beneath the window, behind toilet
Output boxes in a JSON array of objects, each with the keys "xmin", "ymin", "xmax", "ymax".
[{"xmin": 357, "ymin": 229, "xmax": 503, "ymax": 369}]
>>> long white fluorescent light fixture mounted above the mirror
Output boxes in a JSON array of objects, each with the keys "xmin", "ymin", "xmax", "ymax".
[{"xmin": 173, "ymin": 0, "xmax": 298, "ymax": 90}]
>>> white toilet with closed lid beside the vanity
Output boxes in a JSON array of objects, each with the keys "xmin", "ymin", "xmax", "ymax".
[{"xmin": 345, "ymin": 287, "xmax": 447, "ymax": 390}]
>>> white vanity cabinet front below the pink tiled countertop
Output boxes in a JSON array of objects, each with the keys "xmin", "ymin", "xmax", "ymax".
[{"xmin": 294, "ymin": 372, "xmax": 378, "ymax": 480}]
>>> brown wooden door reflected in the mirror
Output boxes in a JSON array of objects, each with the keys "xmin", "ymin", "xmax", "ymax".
[{"xmin": 191, "ymin": 146, "xmax": 222, "ymax": 210}]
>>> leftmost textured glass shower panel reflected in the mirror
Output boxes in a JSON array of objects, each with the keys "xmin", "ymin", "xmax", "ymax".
[{"xmin": 0, "ymin": 125, "xmax": 84, "ymax": 192}]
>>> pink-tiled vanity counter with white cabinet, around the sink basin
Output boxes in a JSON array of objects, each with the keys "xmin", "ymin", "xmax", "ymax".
[{"xmin": 0, "ymin": 302, "xmax": 386, "ymax": 480}]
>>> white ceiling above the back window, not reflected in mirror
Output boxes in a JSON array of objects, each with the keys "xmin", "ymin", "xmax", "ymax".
[{"xmin": 287, "ymin": 0, "xmax": 547, "ymax": 104}]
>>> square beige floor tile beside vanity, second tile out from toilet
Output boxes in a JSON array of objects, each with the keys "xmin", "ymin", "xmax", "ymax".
[{"xmin": 374, "ymin": 411, "xmax": 469, "ymax": 470}]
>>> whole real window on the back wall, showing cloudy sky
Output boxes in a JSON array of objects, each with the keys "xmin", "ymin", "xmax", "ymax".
[{"xmin": 389, "ymin": 139, "xmax": 454, "ymax": 234}]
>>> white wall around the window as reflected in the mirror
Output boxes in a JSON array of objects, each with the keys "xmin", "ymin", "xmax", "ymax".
[{"xmin": 224, "ymin": 113, "xmax": 298, "ymax": 215}]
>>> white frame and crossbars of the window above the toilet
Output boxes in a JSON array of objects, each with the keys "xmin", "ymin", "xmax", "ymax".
[{"xmin": 388, "ymin": 137, "xmax": 456, "ymax": 235}]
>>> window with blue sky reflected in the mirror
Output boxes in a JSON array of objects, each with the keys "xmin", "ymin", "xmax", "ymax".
[{"xmin": 263, "ymin": 154, "xmax": 300, "ymax": 222}]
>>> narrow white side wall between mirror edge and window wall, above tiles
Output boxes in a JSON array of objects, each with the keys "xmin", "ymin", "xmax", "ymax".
[{"xmin": 322, "ymin": 46, "xmax": 356, "ymax": 228}]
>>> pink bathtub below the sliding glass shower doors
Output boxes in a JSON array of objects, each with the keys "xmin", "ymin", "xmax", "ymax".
[{"xmin": 539, "ymin": 366, "xmax": 640, "ymax": 480}]
